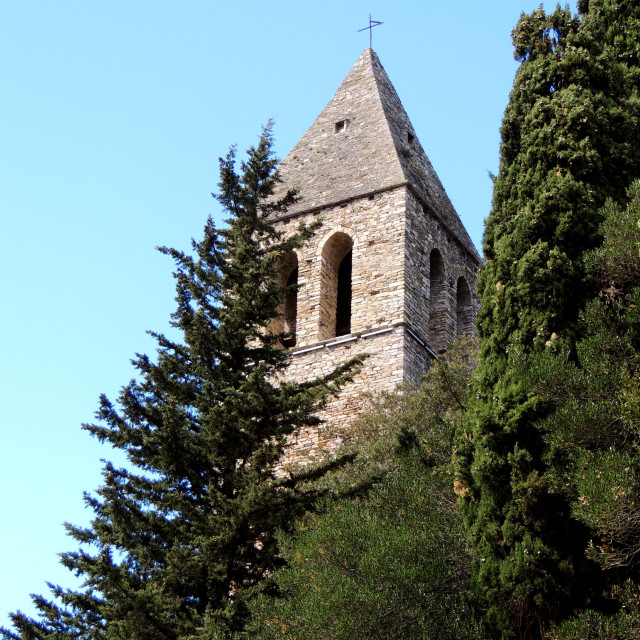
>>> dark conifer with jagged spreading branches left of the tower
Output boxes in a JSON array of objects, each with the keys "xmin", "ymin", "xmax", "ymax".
[{"xmin": 2, "ymin": 126, "xmax": 354, "ymax": 640}]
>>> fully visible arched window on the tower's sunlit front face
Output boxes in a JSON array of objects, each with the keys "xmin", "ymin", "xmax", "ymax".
[{"xmin": 318, "ymin": 231, "xmax": 353, "ymax": 340}]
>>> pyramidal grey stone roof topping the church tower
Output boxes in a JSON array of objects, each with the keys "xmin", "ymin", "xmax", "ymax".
[{"xmin": 280, "ymin": 49, "xmax": 479, "ymax": 259}]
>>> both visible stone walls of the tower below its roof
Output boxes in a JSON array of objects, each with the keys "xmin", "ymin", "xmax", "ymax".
[{"xmin": 276, "ymin": 186, "xmax": 477, "ymax": 464}]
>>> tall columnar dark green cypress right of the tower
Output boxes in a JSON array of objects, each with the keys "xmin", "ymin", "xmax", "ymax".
[{"xmin": 455, "ymin": 5, "xmax": 640, "ymax": 638}]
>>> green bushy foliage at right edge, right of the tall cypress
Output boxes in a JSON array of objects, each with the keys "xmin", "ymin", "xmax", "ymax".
[{"xmin": 520, "ymin": 182, "xmax": 640, "ymax": 639}]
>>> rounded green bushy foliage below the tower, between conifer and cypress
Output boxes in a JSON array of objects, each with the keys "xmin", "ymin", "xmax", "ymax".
[{"xmin": 246, "ymin": 341, "xmax": 484, "ymax": 640}]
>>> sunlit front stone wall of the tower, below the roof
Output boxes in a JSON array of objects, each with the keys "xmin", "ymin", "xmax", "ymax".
[{"xmin": 276, "ymin": 187, "xmax": 406, "ymax": 464}]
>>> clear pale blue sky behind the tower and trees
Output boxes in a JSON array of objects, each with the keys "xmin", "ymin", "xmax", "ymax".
[{"xmin": 0, "ymin": 0, "xmax": 576, "ymax": 625}]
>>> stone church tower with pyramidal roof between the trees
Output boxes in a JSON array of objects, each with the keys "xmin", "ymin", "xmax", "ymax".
[{"xmin": 276, "ymin": 49, "xmax": 480, "ymax": 459}]
